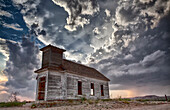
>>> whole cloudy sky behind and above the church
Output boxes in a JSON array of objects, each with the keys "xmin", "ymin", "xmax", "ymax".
[{"xmin": 0, "ymin": 0, "xmax": 170, "ymax": 101}]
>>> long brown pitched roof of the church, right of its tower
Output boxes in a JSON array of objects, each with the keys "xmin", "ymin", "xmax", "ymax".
[{"xmin": 63, "ymin": 59, "xmax": 110, "ymax": 81}]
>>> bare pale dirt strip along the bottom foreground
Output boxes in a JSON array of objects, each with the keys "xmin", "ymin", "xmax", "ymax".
[{"xmin": 0, "ymin": 103, "xmax": 170, "ymax": 110}]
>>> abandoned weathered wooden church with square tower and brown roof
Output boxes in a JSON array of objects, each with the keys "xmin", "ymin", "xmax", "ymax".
[{"xmin": 35, "ymin": 45, "xmax": 109, "ymax": 101}]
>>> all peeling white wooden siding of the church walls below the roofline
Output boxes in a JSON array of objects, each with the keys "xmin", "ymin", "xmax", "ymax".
[{"xmin": 36, "ymin": 71, "xmax": 109, "ymax": 100}]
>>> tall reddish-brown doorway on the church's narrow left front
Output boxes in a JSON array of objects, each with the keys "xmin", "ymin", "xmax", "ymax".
[{"xmin": 38, "ymin": 77, "xmax": 46, "ymax": 100}]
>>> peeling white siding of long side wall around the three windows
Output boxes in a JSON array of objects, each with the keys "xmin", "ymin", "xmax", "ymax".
[{"xmin": 66, "ymin": 73, "xmax": 109, "ymax": 99}]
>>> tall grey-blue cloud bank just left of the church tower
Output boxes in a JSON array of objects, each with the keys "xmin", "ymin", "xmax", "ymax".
[{"xmin": 4, "ymin": 37, "xmax": 40, "ymax": 98}]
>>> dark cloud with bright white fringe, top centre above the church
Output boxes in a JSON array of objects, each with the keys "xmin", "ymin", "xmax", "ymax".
[{"xmin": 52, "ymin": 0, "xmax": 99, "ymax": 31}]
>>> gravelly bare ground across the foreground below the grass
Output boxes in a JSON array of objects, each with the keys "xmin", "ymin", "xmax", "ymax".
[{"xmin": 0, "ymin": 101, "xmax": 170, "ymax": 110}]
